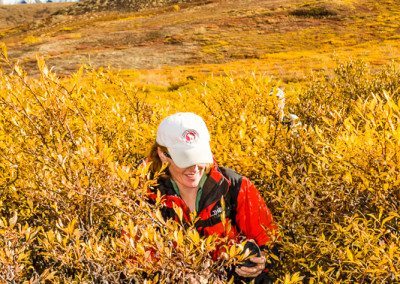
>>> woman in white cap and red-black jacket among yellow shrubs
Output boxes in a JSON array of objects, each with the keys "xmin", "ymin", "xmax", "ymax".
[{"xmin": 149, "ymin": 112, "xmax": 277, "ymax": 283}]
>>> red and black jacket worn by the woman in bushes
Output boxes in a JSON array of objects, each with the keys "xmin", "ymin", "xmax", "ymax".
[{"xmin": 150, "ymin": 164, "xmax": 277, "ymax": 250}]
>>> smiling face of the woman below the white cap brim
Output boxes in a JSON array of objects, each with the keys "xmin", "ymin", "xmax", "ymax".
[{"xmin": 159, "ymin": 148, "xmax": 207, "ymax": 190}]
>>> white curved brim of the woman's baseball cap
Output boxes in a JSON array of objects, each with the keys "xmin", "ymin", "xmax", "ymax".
[{"xmin": 168, "ymin": 144, "xmax": 214, "ymax": 168}]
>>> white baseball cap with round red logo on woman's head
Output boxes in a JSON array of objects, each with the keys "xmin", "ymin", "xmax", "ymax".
[{"xmin": 156, "ymin": 112, "xmax": 213, "ymax": 168}]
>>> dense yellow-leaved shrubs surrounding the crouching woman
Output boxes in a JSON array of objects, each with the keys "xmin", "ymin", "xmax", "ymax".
[{"xmin": 0, "ymin": 48, "xmax": 400, "ymax": 283}]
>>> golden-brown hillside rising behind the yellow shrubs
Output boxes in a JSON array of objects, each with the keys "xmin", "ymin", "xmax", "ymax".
[{"xmin": 0, "ymin": 0, "xmax": 400, "ymax": 81}]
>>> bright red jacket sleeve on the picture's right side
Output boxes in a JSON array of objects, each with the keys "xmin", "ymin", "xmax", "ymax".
[{"xmin": 236, "ymin": 177, "xmax": 277, "ymax": 246}]
